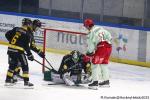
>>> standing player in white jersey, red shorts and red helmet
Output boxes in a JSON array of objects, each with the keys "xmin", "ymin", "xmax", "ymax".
[{"xmin": 84, "ymin": 19, "xmax": 112, "ymax": 89}]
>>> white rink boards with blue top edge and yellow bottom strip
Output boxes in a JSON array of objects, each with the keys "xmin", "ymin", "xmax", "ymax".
[{"xmin": 0, "ymin": 12, "xmax": 150, "ymax": 67}]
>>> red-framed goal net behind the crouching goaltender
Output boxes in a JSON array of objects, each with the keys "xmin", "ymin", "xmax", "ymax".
[{"xmin": 35, "ymin": 28, "xmax": 86, "ymax": 72}]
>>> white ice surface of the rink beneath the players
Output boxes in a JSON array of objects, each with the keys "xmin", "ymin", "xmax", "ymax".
[{"xmin": 0, "ymin": 45, "xmax": 150, "ymax": 100}]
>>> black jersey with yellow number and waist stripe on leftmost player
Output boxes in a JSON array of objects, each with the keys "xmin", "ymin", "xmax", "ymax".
[{"xmin": 5, "ymin": 27, "xmax": 31, "ymax": 54}]
